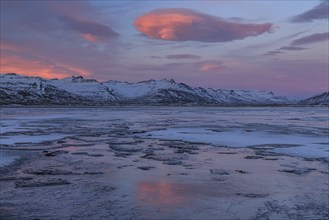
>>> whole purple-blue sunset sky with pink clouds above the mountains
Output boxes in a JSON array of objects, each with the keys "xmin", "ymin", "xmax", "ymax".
[{"xmin": 0, "ymin": 0, "xmax": 329, "ymax": 97}]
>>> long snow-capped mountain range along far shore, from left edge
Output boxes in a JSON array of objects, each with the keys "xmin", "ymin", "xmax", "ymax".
[{"xmin": 0, "ymin": 73, "xmax": 295, "ymax": 105}]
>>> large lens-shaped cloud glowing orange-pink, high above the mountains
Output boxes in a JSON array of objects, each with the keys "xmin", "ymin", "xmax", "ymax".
[{"xmin": 134, "ymin": 9, "xmax": 273, "ymax": 42}]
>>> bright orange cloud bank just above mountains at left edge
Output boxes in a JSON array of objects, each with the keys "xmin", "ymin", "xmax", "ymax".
[{"xmin": 0, "ymin": 54, "xmax": 88, "ymax": 78}]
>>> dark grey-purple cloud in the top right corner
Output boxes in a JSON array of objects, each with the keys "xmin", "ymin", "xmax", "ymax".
[{"xmin": 291, "ymin": 0, "xmax": 329, "ymax": 23}]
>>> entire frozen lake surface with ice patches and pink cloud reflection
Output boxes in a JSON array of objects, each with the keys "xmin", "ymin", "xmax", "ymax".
[{"xmin": 0, "ymin": 107, "xmax": 329, "ymax": 220}]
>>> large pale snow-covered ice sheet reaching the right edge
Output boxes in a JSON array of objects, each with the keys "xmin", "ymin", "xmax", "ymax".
[{"xmin": 145, "ymin": 128, "xmax": 329, "ymax": 158}]
